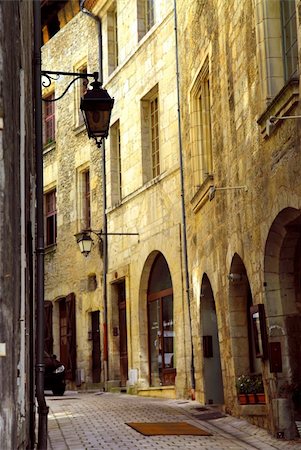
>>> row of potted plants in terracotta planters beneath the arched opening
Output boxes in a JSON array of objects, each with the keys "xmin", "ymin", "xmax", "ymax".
[{"xmin": 236, "ymin": 375, "xmax": 265, "ymax": 405}]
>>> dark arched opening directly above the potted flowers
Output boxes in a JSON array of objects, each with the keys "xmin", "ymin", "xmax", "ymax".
[{"xmin": 228, "ymin": 253, "xmax": 262, "ymax": 376}]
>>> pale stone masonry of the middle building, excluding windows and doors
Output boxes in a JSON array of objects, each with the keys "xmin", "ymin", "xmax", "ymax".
[{"xmin": 95, "ymin": 1, "xmax": 189, "ymax": 396}]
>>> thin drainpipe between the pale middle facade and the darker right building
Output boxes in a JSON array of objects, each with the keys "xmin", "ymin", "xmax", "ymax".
[{"xmin": 174, "ymin": 0, "xmax": 195, "ymax": 400}]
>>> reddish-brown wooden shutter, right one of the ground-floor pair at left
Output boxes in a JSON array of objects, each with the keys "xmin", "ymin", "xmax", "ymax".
[{"xmin": 66, "ymin": 293, "xmax": 76, "ymax": 381}]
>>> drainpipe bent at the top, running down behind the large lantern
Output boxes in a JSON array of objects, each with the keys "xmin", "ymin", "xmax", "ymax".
[{"xmin": 79, "ymin": 0, "xmax": 109, "ymax": 388}]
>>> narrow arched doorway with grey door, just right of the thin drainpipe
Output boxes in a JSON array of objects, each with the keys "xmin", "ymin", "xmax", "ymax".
[{"xmin": 201, "ymin": 274, "xmax": 224, "ymax": 404}]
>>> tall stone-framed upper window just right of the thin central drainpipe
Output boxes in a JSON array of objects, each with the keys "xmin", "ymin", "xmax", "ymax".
[{"xmin": 191, "ymin": 58, "xmax": 213, "ymax": 188}]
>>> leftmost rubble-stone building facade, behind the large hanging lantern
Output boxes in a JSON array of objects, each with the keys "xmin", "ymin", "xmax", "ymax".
[{"xmin": 42, "ymin": 2, "xmax": 104, "ymax": 387}]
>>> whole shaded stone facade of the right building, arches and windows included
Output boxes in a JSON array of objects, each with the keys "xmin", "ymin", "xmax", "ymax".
[{"xmin": 177, "ymin": 0, "xmax": 301, "ymax": 437}]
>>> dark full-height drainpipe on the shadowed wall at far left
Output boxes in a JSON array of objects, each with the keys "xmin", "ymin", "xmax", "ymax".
[{"xmin": 33, "ymin": 0, "xmax": 49, "ymax": 450}]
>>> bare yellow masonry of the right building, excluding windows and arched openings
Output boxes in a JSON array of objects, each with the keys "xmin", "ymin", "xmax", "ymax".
[{"xmin": 177, "ymin": 0, "xmax": 301, "ymax": 430}]
